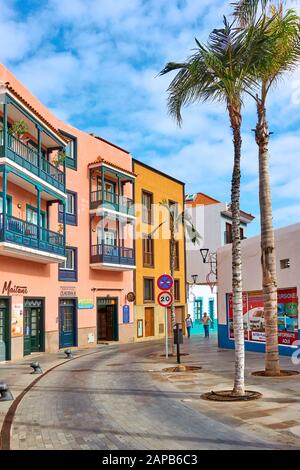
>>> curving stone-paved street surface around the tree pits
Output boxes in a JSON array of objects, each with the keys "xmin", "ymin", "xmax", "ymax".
[{"xmin": 4, "ymin": 337, "xmax": 300, "ymax": 450}]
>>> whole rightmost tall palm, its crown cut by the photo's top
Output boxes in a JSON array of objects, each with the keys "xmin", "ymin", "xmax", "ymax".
[{"xmin": 234, "ymin": 0, "xmax": 300, "ymax": 376}]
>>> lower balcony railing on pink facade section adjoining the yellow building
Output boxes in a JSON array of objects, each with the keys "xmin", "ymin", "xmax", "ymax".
[{"xmin": 91, "ymin": 243, "xmax": 135, "ymax": 266}]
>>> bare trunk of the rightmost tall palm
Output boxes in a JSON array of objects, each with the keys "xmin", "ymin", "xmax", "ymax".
[{"xmin": 256, "ymin": 93, "xmax": 280, "ymax": 376}]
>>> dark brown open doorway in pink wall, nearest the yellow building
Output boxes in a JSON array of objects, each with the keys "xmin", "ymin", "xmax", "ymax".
[{"xmin": 97, "ymin": 297, "xmax": 119, "ymax": 343}]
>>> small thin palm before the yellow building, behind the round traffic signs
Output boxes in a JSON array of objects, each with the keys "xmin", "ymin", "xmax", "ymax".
[{"xmin": 150, "ymin": 199, "xmax": 202, "ymax": 354}]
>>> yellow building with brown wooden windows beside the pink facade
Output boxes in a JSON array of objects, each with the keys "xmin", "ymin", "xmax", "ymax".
[{"xmin": 133, "ymin": 160, "xmax": 186, "ymax": 341}]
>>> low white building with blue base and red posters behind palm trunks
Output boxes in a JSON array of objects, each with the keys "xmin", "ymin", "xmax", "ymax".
[{"xmin": 217, "ymin": 223, "xmax": 300, "ymax": 355}]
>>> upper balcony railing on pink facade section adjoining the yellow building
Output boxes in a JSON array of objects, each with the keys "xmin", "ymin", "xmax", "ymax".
[{"xmin": 90, "ymin": 190, "xmax": 134, "ymax": 215}]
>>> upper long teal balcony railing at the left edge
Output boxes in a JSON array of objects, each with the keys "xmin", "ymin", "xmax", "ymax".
[{"xmin": 0, "ymin": 131, "xmax": 66, "ymax": 192}]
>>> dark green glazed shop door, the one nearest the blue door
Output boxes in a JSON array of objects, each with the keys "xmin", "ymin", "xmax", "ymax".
[{"xmin": 24, "ymin": 299, "xmax": 45, "ymax": 356}]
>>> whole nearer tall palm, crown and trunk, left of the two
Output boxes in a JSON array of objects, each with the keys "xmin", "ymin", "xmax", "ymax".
[{"xmin": 161, "ymin": 18, "xmax": 259, "ymax": 396}]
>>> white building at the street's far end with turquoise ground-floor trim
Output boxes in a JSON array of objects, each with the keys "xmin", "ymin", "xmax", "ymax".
[{"xmin": 186, "ymin": 193, "xmax": 254, "ymax": 332}]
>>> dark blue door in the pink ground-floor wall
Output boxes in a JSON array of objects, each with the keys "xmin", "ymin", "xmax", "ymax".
[{"xmin": 59, "ymin": 299, "xmax": 77, "ymax": 348}]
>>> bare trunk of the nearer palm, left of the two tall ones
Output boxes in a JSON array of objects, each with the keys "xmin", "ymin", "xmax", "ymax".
[{"xmin": 228, "ymin": 105, "xmax": 245, "ymax": 396}]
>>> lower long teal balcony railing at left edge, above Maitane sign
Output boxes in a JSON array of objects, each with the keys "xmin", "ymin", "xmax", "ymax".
[{"xmin": 0, "ymin": 213, "xmax": 65, "ymax": 256}]
